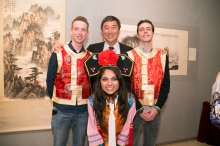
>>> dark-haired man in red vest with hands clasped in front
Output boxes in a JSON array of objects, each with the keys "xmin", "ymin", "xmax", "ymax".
[{"xmin": 127, "ymin": 20, "xmax": 170, "ymax": 146}]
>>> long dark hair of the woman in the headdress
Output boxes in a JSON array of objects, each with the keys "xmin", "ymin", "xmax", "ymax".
[{"xmin": 93, "ymin": 66, "xmax": 129, "ymax": 131}]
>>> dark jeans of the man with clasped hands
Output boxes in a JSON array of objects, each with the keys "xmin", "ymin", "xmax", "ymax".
[{"xmin": 133, "ymin": 107, "xmax": 161, "ymax": 146}]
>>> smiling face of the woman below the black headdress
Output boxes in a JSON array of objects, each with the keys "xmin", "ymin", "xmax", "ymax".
[{"xmin": 100, "ymin": 69, "xmax": 119, "ymax": 95}]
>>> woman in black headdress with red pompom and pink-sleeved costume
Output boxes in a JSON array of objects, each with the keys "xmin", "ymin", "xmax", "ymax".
[{"xmin": 85, "ymin": 50, "xmax": 136, "ymax": 146}]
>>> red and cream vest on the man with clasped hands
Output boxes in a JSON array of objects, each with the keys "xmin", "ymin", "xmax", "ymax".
[{"xmin": 128, "ymin": 48, "xmax": 166, "ymax": 106}]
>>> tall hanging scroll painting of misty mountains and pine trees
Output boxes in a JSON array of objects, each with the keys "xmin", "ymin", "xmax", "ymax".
[{"xmin": 0, "ymin": 0, "xmax": 65, "ymax": 133}]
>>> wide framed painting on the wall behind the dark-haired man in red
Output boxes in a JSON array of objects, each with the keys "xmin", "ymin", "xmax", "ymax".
[{"xmin": 118, "ymin": 24, "xmax": 188, "ymax": 75}]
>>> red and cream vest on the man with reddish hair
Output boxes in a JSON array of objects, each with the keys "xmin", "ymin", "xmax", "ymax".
[{"xmin": 53, "ymin": 45, "xmax": 91, "ymax": 105}]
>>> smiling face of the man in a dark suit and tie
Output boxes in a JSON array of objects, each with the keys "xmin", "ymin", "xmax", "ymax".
[{"xmin": 102, "ymin": 20, "xmax": 120, "ymax": 46}]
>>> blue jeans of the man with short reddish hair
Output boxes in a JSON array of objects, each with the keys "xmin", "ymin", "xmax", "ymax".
[{"xmin": 51, "ymin": 107, "xmax": 88, "ymax": 146}]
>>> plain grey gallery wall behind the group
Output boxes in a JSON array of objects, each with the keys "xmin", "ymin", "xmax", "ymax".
[{"xmin": 0, "ymin": 0, "xmax": 220, "ymax": 146}]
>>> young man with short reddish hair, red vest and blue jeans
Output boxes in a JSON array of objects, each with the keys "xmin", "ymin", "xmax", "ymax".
[{"xmin": 46, "ymin": 16, "xmax": 91, "ymax": 146}]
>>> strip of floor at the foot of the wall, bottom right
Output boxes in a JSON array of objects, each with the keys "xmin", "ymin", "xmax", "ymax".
[{"xmin": 156, "ymin": 139, "xmax": 211, "ymax": 146}]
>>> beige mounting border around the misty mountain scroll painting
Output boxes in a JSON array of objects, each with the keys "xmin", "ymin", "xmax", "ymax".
[{"xmin": 0, "ymin": 0, "xmax": 65, "ymax": 133}]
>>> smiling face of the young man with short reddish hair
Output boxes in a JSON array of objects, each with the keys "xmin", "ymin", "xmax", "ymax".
[{"xmin": 70, "ymin": 20, "xmax": 88, "ymax": 44}]
